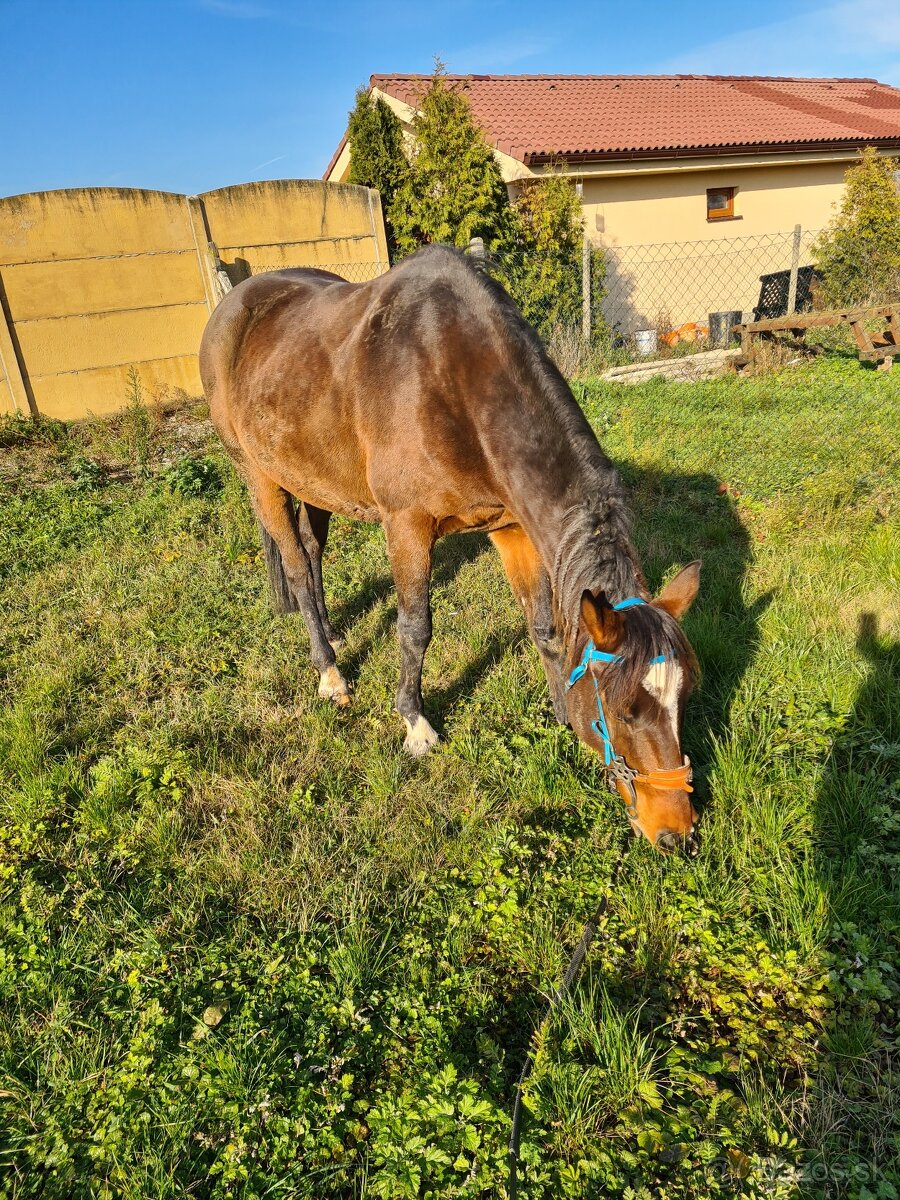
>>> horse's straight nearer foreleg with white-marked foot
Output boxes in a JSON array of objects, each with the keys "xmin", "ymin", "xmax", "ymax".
[{"xmin": 384, "ymin": 511, "xmax": 438, "ymax": 755}]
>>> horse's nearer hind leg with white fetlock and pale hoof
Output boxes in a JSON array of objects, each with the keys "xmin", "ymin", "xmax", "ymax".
[{"xmin": 254, "ymin": 474, "xmax": 350, "ymax": 707}]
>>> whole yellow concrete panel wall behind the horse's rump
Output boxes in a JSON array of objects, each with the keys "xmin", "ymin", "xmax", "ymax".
[{"xmin": 0, "ymin": 180, "xmax": 388, "ymax": 419}]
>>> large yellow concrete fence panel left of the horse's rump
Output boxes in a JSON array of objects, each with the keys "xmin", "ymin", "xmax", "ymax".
[{"xmin": 0, "ymin": 187, "xmax": 208, "ymax": 418}]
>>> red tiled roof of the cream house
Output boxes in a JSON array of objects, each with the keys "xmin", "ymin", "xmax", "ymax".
[{"xmin": 370, "ymin": 74, "xmax": 900, "ymax": 162}]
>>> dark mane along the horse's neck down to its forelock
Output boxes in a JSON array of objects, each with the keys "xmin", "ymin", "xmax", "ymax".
[{"xmin": 391, "ymin": 246, "xmax": 694, "ymax": 702}]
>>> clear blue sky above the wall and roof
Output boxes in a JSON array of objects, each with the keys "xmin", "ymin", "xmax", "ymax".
[{"xmin": 0, "ymin": 0, "xmax": 900, "ymax": 196}]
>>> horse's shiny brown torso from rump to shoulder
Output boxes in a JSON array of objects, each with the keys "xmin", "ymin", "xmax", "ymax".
[{"xmin": 200, "ymin": 247, "xmax": 550, "ymax": 527}]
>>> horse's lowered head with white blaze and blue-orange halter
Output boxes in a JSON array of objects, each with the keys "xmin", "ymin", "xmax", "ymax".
[{"xmin": 568, "ymin": 563, "xmax": 700, "ymax": 853}]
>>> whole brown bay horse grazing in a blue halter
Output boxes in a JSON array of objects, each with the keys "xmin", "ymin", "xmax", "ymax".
[{"xmin": 200, "ymin": 246, "xmax": 700, "ymax": 851}]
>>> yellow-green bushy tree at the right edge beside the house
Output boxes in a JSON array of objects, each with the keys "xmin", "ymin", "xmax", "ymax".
[{"xmin": 814, "ymin": 146, "xmax": 900, "ymax": 306}]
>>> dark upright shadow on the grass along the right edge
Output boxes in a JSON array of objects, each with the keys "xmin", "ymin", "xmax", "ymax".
[{"xmin": 804, "ymin": 612, "xmax": 900, "ymax": 1198}]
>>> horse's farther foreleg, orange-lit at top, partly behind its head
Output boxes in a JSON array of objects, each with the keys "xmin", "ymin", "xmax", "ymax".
[{"xmin": 491, "ymin": 526, "xmax": 569, "ymax": 725}]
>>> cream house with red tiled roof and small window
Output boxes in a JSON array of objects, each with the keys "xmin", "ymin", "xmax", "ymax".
[{"xmin": 325, "ymin": 74, "xmax": 900, "ymax": 328}]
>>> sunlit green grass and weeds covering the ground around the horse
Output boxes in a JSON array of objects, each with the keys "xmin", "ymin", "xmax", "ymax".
[{"xmin": 0, "ymin": 361, "xmax": 900, "ymax": 1200}]
